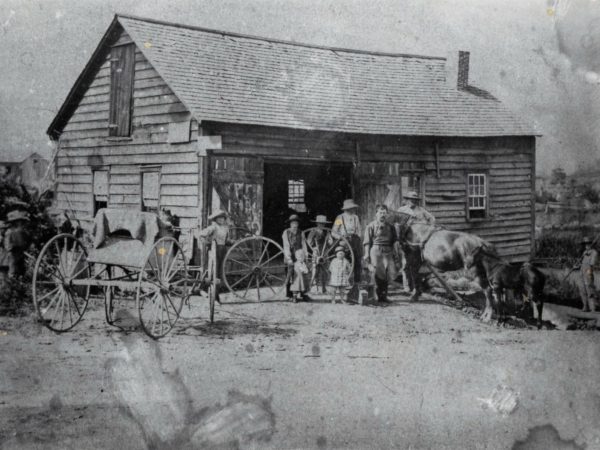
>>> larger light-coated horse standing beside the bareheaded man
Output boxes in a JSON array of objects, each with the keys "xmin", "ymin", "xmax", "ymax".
[{"xmin": 394, "ymin": 214, "xmax": 493, "ymax": 322}]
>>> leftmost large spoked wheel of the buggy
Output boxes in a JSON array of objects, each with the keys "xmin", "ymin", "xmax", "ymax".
[{"xmin": 32, "ymin": 234, "xmax": 91, "ymax": 332}]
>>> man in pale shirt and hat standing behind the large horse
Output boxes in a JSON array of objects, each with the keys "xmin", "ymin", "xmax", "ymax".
[{"xmin": 398, "ymin": 191, "xmax": 435, "ymax": 292}]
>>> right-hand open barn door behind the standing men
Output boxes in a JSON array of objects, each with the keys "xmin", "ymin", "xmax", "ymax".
[{"xmin": 355, "ymin": 162, "xmax": 424, "ymax": 227}]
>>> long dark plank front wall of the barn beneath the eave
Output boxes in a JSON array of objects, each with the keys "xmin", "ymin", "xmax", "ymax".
[{"xmin": 207, "ymin": 124, "xmax": 535, "ymax": 261}]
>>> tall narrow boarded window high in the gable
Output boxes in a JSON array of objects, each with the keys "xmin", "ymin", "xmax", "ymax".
[{"xmin": 108, "ymin": 44, "xmax": 135, "ymax": 136}]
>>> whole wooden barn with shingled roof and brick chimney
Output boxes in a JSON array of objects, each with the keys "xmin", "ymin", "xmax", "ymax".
[{"xmin": 48, "ymin": 15, "xmax": 536, "ymax": 260}]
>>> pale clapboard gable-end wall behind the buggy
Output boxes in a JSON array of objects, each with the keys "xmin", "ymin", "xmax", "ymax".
[{"xmin": 57, "ymin": 29, "xmax": 199, "ymax": 227}]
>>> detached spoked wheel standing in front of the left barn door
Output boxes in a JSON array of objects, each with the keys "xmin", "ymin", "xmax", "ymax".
[{"xmin": 223, "ymin": 236, "xmax": 286, "ymax": 301}]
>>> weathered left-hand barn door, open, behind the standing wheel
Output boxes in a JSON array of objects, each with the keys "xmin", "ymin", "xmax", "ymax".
[{"xmin": 209, "ymin": 156, "xmax": 264, "ymax": 234}]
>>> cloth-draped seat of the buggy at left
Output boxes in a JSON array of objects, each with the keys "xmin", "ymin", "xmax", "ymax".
[{"xmin": 88, "ymin": 208, "xmax": 170, "ymax": 268}]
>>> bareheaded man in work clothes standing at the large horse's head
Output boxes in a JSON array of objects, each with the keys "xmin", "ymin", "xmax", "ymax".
[{"xmin": 364, "ymin": 205, "xmax": 398, "ymax": 302}]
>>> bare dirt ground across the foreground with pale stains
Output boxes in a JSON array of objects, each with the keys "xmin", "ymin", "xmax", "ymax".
[{"xmin": 0, "ymin": 288, "xmax": 600, "ymax": 449}]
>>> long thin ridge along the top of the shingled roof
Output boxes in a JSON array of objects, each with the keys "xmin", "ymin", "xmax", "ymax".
[{"xmin": 115, "ymin": 13, "xmax": 446, "ymax": 61}]
